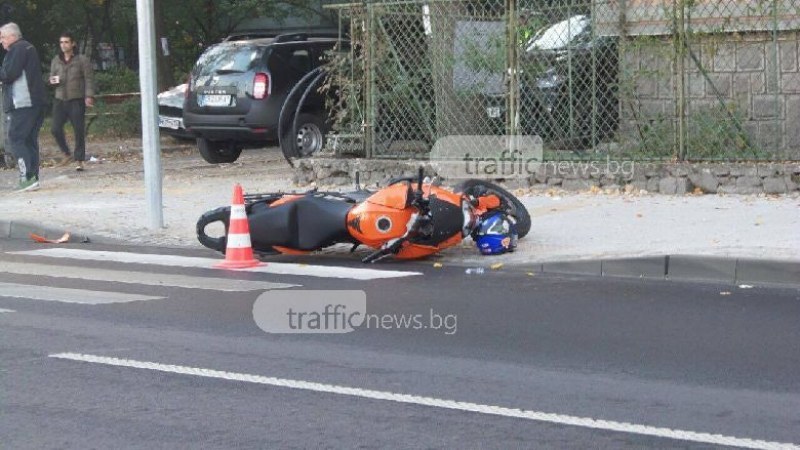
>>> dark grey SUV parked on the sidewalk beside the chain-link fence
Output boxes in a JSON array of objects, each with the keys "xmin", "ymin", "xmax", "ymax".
[{"xmin": 183, "ymin": 34, "xmax": 337, "ymax": 164}]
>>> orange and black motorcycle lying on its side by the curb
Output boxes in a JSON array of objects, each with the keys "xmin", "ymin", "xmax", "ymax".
[{"xmin": 197, "ymin": 169, "xmax": 531, "ymax": 263}]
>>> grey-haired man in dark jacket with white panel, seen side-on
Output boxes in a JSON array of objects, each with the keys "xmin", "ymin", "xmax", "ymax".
[{"xmin": 0, "ymin": 23, "xmax": 46, "ymax": 192}]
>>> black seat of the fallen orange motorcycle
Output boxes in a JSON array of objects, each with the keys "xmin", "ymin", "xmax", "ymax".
[{"xmin": 247, "ymin": 195, "xmax": 353, "ymax": 250}]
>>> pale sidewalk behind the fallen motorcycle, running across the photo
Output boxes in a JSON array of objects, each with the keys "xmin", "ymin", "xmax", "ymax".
[{"xmin": 0, "ymin": 141, "xmax": 800, "ymax": 284}]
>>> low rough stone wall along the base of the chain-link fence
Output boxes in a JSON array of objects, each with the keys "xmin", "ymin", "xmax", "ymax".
[{"xmin": 294, "ymin": 158, "xmax": 800, "ymax": 195}]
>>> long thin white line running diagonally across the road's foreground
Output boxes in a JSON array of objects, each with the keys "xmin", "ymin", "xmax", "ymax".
[{"xmin": 50, "ymin": 353, "xmax": 800, "ymax": 450}]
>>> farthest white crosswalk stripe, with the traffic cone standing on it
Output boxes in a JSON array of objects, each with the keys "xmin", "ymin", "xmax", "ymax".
[{"xmin": 10, "ymin": 248, "xmax": 422, "ymax": 280}]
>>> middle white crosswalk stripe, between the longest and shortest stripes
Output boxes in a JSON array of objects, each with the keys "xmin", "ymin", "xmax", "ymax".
[{"xmin": 0, "ymin": 261, "xmax": 298, "ymax": 292}]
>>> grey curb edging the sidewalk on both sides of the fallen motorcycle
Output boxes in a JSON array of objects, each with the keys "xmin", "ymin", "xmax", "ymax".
[{"xmin": 0, "ymin": 220, "xmax": 800, "ymax": 287}]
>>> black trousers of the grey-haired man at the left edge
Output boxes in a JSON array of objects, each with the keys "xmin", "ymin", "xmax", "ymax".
[{"xmin": 7, "ymin": 106, "xmax": 44, "ymax": 179}]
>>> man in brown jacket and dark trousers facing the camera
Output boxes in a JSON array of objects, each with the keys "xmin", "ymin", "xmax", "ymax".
[{"xmin": 50, "ymin": 33, "xmax": 94, "ymax": 171}]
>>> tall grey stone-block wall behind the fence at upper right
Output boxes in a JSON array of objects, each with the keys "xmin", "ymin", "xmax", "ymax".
[{"xmin": 620, "ymin": 31, "xmax": 800, "ymax": 160}]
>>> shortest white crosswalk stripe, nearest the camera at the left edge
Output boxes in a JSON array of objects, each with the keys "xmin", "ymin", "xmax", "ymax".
[{"xmin": 0, "ymin": 283, "xmax": 164, "ymax": 305}]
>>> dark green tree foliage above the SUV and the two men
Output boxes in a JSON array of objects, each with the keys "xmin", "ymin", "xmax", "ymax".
[{"xmin": 0, "ymin": 0, "xmax": 326, "ymax": 92}]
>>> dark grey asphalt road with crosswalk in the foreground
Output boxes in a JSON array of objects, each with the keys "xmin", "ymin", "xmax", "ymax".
[{"xmin": 0, "ymin": 237, "xmax": 800, "ymax": 449}]
